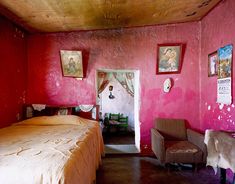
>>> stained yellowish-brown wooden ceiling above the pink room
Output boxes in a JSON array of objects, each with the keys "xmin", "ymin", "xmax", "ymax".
[{"xmin": 0, "ymin": 0, "xmax": 221, "ymax": 32}]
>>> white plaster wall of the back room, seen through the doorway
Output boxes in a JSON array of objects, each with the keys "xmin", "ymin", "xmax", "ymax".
[{"xmin": 100, "ymin": 78, "xmax": 135, "ymax": 130}]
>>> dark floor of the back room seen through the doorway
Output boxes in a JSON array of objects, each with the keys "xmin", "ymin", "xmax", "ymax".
[{"xmin": 103, "ymin": 132, "xmax": 135, "ymax": 144}]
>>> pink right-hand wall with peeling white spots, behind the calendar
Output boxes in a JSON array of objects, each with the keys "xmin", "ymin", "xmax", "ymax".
[{"xmin": 200, "ymin": 0, "xmax": 235, "ymax": 130}]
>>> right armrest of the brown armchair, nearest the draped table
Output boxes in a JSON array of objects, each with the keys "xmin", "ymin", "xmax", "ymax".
[{"xmin": 187, "ymin": 129, "xmax": 207, "ymax": 163}]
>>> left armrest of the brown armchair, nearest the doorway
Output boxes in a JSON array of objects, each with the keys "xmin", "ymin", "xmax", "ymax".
[{"xmin": 151, "ymin": 128, "xmax": 165, "ymax": 163}]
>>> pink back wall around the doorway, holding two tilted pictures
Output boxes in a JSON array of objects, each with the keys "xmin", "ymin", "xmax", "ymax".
[{"xmin": 27, "ymin": 23, "xmax": 199, "ymax": 153}]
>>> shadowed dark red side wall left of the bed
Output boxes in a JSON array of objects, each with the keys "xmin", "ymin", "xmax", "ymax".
[{"xmin": 0, "ymin": 16, "xmax": 27, "ymax": 128}]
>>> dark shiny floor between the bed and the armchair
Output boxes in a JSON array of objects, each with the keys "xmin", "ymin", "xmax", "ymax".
[{"xmin": 96, "ymin": 156, "xmax": 219, "ymax": 184}]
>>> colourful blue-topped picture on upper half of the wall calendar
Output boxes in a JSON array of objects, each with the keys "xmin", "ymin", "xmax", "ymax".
[{"xmin": 218, "ymin": 45, "xmax": 233, "ymax": 79}]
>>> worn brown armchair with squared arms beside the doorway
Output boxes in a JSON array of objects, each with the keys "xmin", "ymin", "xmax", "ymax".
[{"xmin": 151, "ymin": 118, "xmax": 207, "ymax": 169}]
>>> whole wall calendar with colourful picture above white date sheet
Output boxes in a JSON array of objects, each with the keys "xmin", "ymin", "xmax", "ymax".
[{"xmin": 217, "ymin": 45, "xmax": 233, "ymax": 104}]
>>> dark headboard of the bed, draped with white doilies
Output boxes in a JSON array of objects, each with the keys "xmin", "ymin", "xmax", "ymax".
[{"xmin": 24, "ymin": 104, "xmax": 99, "ymax": 121}]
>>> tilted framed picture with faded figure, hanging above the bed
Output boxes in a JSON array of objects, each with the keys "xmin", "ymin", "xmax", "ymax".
[{"xmin": 60, "ymin": 50, "xmax": 84, "ymax": 78}]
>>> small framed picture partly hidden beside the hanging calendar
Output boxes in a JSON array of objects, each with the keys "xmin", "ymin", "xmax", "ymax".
[{"xmin": 208, "ymin": 51, "xmax": 219, "ymax": 77}]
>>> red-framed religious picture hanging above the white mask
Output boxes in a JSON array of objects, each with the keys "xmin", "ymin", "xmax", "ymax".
[{"xmin": 157, "ymin": 43, "xmax": 183, "ymax": 74}]
